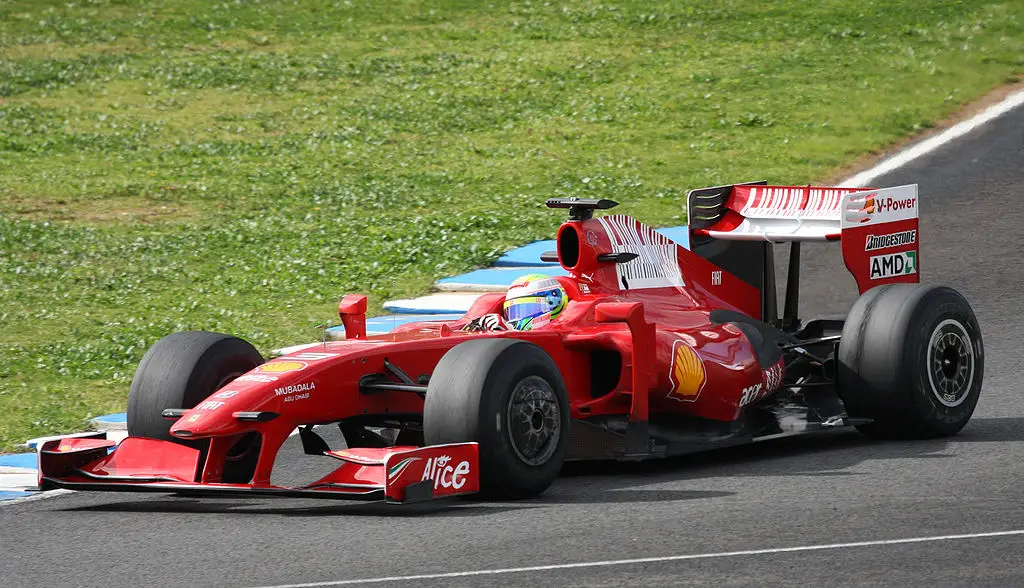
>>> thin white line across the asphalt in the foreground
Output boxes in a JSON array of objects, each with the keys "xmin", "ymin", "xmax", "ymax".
[{"xmin": 249, "ymin": 529, "xmax": 1024, "ymax": 588}]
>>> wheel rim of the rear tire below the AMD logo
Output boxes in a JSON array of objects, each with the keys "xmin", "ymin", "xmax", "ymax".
[{"xmin": 928, "ymin": 319, "xmax": 975, "ymax": 408}]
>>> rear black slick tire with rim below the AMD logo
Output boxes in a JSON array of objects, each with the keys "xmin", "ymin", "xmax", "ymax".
[{"xmin": 837, "ymin": 284, "xmax": 985, "ymax": 438}]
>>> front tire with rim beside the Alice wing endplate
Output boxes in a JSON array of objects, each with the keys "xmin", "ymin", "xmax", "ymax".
[{"xmin": 423, "ymin": 338, "xmax": 569, "ymax": 499}]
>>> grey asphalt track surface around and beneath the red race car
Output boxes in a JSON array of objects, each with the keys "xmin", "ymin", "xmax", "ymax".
[{"xmin": 0, "ymin": 103, "xmax": 1024, "ymax": 588}]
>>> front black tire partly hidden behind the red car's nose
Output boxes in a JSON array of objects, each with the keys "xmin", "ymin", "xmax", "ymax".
[{"xmin": 128, "ymin": 331, "xmax": 263, "ymax": 447}]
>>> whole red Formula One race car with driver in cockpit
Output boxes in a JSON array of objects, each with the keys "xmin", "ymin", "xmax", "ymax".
[{"xmin": 39, "ymin": 182, "xmax": 984, "ymax": 503}]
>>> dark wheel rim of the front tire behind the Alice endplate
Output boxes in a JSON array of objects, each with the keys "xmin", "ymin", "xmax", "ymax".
[{"xmin": 508, "ymin": 376, "xmax": 561, "ymax": 466}]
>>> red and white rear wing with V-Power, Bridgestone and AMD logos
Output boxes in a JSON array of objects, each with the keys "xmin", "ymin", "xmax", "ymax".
[{"xmin": 687, "ymin": 182, "xmax": 920, "ymax": 322}]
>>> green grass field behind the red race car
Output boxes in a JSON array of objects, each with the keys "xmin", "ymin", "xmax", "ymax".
[{"xmin": 0, "ymin": 0, "xmax": 1024, "ymax": 450}]
